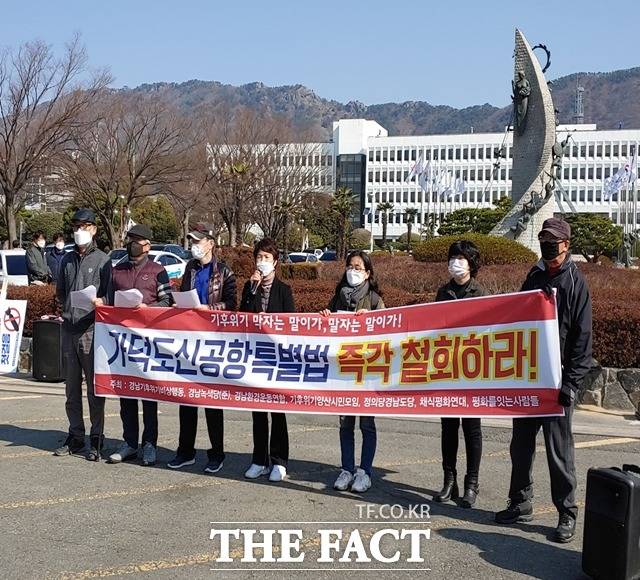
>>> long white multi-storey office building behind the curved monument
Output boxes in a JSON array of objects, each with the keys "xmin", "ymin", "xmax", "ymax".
[{"xmin": 333, "ymin": 119, "xmax": 640, "ymax": 239}]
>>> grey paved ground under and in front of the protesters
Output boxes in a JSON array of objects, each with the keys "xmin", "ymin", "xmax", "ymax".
[{"xmin": 0, "ymin": 378, "xmax": 640, "ymax": 579}]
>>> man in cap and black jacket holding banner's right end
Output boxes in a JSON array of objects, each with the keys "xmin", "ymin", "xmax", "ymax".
[{"xmin": 496, "ymin": 218, "xmax": 592, "ymax": 543}]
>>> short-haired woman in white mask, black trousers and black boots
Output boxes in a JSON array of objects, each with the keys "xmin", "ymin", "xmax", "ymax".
[{"xmin": 434, "ymin": 240, "xmax": 487, "ymax": 508}]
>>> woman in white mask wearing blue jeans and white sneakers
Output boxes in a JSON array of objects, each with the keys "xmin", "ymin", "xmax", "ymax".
[{"xmin": 320, "ymin": 250, "xmax": 384, "ymax": 493}]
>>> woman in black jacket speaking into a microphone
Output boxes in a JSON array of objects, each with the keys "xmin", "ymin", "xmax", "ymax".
[{"xmin": 239, "ymin": 238, "xmax": 296, "ymax": 482}]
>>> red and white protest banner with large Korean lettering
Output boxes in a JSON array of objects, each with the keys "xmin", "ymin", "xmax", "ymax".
[{"xmin": 95, "ymin": 291, "xmax": 563, "ymax": 417}]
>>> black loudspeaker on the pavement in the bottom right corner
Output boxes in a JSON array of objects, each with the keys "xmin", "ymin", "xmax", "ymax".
[{"xmin": 582, "ymin": 465, "xmax": 640, "ymax": 580}]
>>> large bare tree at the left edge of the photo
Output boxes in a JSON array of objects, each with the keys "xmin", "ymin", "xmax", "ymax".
[{"xmin": 0, "ymin": 37, "xmax": 111, "ymax": 241}]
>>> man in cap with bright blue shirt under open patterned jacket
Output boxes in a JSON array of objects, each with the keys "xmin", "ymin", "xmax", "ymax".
[{"xmin": 167, "ymin": 231, "xmax": 237, "ymax": 473}]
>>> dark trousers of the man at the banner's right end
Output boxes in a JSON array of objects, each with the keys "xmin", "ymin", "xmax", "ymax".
[{"xmin": 509, "ymin": 408, "xmax": 578, "ymax": 518}]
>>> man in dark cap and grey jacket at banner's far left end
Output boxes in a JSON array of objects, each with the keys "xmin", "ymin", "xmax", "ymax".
[{"xmin": 54, "ymin": 208, "xmax": 111, "ymax": 461}]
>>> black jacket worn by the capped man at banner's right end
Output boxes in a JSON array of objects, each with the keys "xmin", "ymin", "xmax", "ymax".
[{"xmin": 522, "ymin": 255, "xmax": 592, "ymax": 392}]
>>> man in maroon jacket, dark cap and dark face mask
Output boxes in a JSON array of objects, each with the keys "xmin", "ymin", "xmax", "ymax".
[{"xmin": 106, "ymin": 224, "xmax": 171, "ymax": 465}]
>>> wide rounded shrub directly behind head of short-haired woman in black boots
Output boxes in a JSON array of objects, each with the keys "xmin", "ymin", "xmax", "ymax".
[{"xmin": 413, "ymin": 234, "xmax": 538, "ymax": 265}]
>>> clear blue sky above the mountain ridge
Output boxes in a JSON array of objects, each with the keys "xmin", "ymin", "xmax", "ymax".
[{"xmin": 0, "ymin": 0, "xmax": 640, "ymax": 107}]
